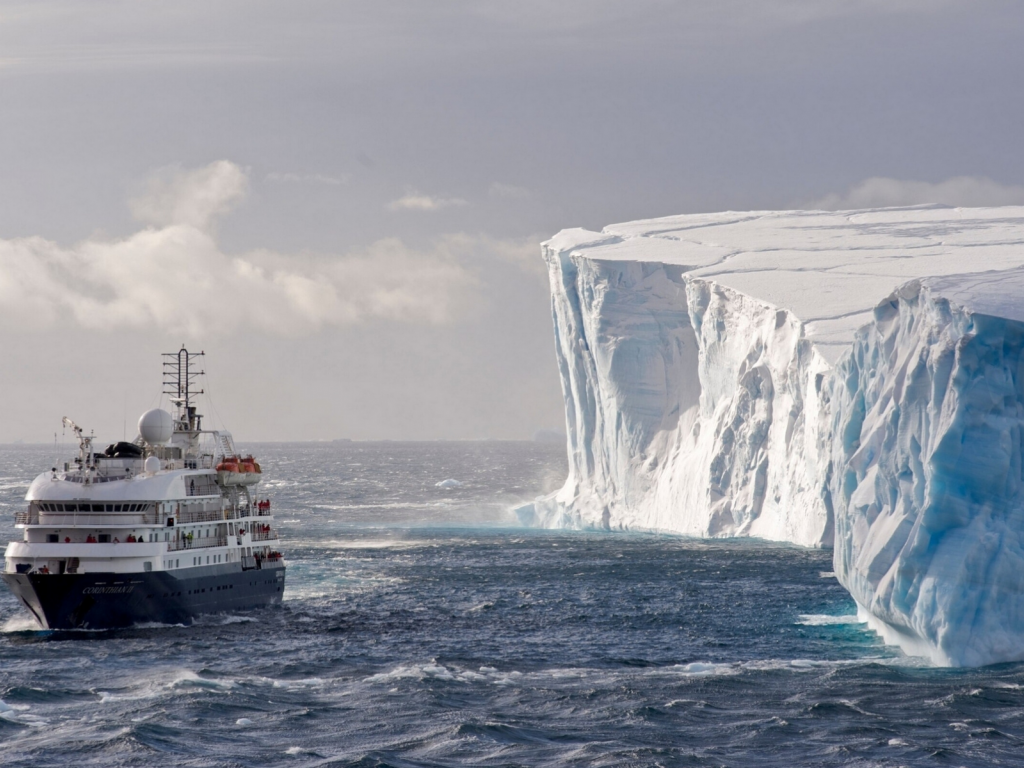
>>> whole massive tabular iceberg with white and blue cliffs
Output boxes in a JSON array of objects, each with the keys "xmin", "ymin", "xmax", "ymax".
[{"xmin": 519, "ymin": 207, "xmax": 1024, "ymax": 665}]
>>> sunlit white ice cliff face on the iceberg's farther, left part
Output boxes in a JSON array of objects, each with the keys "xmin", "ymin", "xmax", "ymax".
[{"xmin": 536, "ymin": 251, "xmax": 830, "ymax": 545}]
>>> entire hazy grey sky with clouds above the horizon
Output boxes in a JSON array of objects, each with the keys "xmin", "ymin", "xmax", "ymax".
[{"xmin": 0, "ymin": 0, "xmax": 1024, "ymax": 442}]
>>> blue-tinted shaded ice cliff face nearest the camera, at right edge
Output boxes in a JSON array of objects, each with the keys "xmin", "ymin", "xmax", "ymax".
[{"xmin": 831, "ymin": 270, "xmax": 1024, "ymax": 666}]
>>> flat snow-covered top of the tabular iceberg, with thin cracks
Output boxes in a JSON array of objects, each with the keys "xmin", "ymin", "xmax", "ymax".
[{"xmin": 545, "ymin": 206, "xmax": 1024, "ymax": 359}]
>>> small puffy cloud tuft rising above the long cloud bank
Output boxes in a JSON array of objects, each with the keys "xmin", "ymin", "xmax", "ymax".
[{"xmin": 128, "ymin": 160, "xmax": 249, "ymax": 229}]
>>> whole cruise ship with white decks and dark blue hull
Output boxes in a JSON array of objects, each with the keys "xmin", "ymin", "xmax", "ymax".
[{"xmin": 2, "ymin": 347, "xmax": 285, "ymax": 630}]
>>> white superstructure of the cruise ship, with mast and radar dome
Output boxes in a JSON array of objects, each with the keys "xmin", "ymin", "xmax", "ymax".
[{"xmin": 4, "ymin": 348, "xmax": 281, "ymax": 573}]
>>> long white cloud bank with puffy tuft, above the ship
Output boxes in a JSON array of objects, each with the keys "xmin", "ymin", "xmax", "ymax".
[{"xmin": 0, "ymin": 161, "xmax": 480, "ymax": 337}]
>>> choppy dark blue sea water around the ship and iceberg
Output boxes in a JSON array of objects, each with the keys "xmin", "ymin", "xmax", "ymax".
[{"xmin": 0, "ymin": 442, "xmax": 1024, "ymax": 768}]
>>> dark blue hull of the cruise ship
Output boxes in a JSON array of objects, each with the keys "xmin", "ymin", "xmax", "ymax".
[{"xmin": 2, "ymin": 563, "xmax": 285, "ymax": 630}]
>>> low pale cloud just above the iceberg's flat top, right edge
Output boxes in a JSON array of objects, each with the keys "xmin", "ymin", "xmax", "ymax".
[{"xmin": 803, "ymin": 176, "xmax": 1024, "ymax": 211}]
